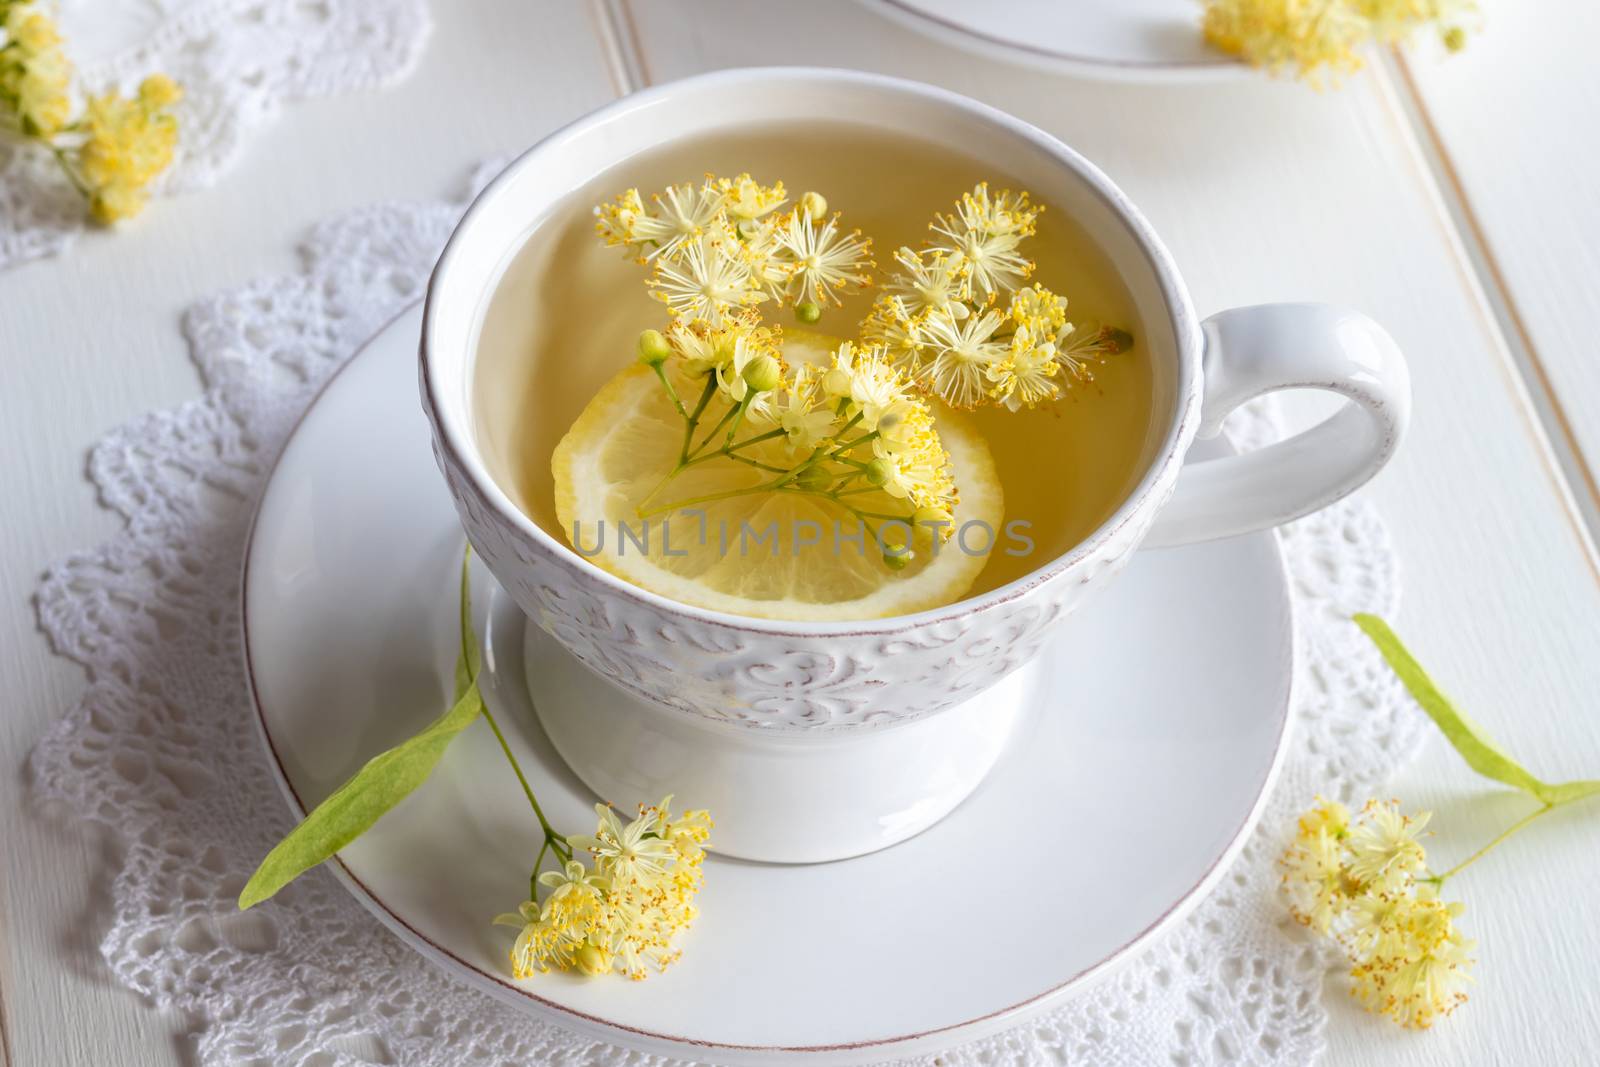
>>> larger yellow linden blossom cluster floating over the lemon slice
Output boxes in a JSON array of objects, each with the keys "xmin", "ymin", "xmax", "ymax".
[{"xmin": 595, "ymin": 174, "xmax": 958, "ymax": 571}]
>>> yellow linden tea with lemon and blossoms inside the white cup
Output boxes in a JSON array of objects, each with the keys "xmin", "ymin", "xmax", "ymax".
[{"xmin": 475, "ymin": 123, "xmax": 1154, "ymax": 621}]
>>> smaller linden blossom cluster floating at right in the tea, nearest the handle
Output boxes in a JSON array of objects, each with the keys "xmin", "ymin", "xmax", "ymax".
[{"xmin": 861, "ymin": 182, "xmax": 1133, "ymax": 411}]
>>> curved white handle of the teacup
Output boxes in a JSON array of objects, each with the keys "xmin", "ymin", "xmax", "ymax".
[{"xmin": 1146, "ymin": 304, "xmax": 1411, "ymax": 547}]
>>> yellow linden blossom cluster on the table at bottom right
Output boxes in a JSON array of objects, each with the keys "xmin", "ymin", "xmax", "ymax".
[{"xmin": 1280, "ymin": 798, "xmax": 1475, "ymax": 1030}]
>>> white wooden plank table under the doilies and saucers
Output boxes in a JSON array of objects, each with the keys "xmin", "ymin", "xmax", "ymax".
[{"xmin": 0, "ymin": 0, "xmax": 1600, "ymax": 1067}]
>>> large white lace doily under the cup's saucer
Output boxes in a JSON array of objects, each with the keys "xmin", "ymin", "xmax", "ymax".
[{"xmin": 32, "ymin": 179, "xmax": 1424, "ymax": 1067}]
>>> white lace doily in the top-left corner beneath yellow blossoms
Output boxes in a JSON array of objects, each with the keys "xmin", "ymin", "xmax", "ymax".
[{"xmin": 0, "ymin": 0, "xmax": 430, "ymax": 270}]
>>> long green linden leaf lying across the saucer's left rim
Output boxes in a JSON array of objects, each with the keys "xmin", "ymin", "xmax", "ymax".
[{"xmin": 238, "ymin": 558, "xmax": 483, "ymax": 910}]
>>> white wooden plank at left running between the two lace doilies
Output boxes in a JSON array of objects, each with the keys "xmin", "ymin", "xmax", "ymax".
[{"xmin": 0, "ymin": 0, "xmax": 616, "ymax": 1067}]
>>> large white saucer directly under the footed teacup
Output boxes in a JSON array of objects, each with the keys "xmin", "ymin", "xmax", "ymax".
[{"xmin": 245, "ymin": 303, "xmax": 1293, "ymax": 1064}]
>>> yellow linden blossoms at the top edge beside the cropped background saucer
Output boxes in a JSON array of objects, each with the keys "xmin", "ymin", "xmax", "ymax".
[{"xmin": 1203, "ymin": 0, "xmax": 1477, "ymax": 82}]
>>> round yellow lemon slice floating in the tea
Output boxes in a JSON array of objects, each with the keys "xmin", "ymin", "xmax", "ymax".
[{"xmin": 550, "ymin": 330, "xmax": 1002, "ymax": 621}]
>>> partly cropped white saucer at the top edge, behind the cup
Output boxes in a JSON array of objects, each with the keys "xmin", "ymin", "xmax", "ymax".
[{"xmin": 866, "ymin": 0, "xmax": 1250, "ymax": 82}]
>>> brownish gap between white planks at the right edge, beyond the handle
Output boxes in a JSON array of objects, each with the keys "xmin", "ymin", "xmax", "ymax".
[{"xmin": 1376, "ymin": 48, "xmax": 1600, "ymax": 579}]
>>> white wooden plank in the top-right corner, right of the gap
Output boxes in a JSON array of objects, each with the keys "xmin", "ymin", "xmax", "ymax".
[{"xmin": 1397, "ymin": 0, "xmax": 1600, "ymax": 536}]
